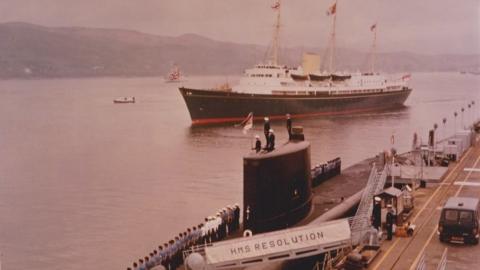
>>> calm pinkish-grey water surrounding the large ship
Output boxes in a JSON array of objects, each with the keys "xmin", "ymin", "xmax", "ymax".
[{"xmin": 0, "ymin": 73, "xmax": 480, "ymax": 270}]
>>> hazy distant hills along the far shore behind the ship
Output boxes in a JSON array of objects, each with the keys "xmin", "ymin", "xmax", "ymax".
[{"xmin": 0, "ymin": 22, "xmax": 480, "ymax": 78}]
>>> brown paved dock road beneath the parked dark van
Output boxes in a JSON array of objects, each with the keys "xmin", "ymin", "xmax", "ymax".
[{"xmin": 369, "ymin": 139, "xmax": 480, "ymax": 270}]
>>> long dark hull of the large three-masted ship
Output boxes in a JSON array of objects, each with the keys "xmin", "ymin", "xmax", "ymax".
[{"xmin": 180, "ymin": 87, "xmax": 412, "ymax": 125}]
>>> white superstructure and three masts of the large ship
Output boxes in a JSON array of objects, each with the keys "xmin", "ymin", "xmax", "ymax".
[{"xmin": 232, "ymin": 1, "xmax": 410, "ymax": 94}]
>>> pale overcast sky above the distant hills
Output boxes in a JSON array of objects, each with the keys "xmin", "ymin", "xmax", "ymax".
[{"xmin": 0, "ymin": 0, "xmax": 480, "ymax": 54}]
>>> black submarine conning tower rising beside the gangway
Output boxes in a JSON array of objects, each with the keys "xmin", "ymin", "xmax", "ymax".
[{"xmin": 243, "ymin": 127, "xmax": 312, "ymax": 233}]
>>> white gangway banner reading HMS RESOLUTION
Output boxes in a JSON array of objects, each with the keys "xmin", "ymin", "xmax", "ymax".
[{"xmin": 205, "ymin": 220, "xmax": 350, "ymax": 264}]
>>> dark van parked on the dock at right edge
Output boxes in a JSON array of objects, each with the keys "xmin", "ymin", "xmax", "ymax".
[{"xmin": 437, "ymin": 197, "xmax": 480, "ymax": 245}]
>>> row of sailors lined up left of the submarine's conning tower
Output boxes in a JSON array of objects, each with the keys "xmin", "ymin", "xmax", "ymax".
[{"xmin": 127, "ymin": 204, "xmax": 240, "ymax": 270}]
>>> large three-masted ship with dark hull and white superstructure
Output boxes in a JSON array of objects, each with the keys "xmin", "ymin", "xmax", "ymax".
[{"xmin": 179, "ymin": 1, "xmax": 412, "ymax": 125}]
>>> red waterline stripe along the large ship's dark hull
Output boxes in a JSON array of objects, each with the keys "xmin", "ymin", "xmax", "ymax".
[{"xmin": 192, "ymin": 106, "xmax": 402, "ymax": 125}]
